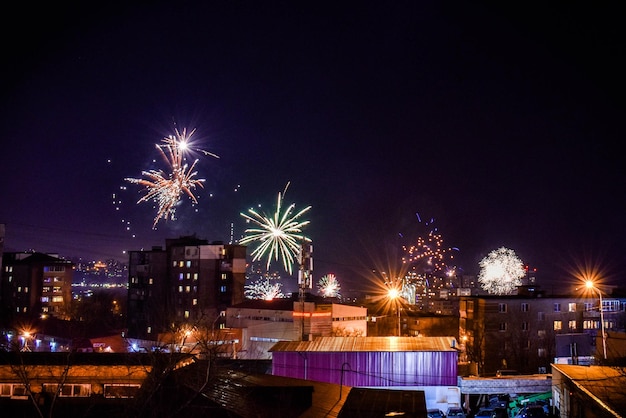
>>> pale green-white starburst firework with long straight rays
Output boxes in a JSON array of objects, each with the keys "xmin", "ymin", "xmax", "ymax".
[{"xmin": 239, "ymin": 183, "xmax": 311, "ymax": 274}]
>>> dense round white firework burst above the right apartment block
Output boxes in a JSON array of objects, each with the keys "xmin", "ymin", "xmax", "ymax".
[{"xmin": 478, "ymin": 247, "xmax": 526, "ymax": 295}]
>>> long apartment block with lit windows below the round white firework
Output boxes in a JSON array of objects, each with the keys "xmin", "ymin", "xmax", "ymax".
[{"xmin": 459, "ymin": 291, "xmax": 626, "ymax": 375}]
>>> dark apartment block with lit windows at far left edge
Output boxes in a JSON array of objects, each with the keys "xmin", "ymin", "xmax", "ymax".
[{"xmin": 0, "ymin": 252, "xmax": 74, "ymax": 322}]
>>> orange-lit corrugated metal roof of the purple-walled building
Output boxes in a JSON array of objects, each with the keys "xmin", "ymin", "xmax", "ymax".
[{"xmin": 269, "ymin": 337, "xmax": 456, "ymax": 352}]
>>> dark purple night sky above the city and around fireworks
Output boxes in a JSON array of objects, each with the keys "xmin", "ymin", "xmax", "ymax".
[{"xmin": 0, "ymin": 1, "xmax": 626, "ymax": 287}]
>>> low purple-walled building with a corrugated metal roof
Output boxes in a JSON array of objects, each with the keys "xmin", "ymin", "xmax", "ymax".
[{"xmin": 270, "ymin": 337, "xmax": 461, "ymax": 410}]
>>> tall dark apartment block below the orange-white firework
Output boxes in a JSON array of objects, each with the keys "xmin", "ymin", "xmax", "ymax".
[{"xmin": 128, "ymin": 237, "xmax": 246, "ymax": 340}]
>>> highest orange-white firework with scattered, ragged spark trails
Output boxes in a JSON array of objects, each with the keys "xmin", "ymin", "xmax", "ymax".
[{"xmin": 125, "ymin": 129, "xmax": 219, "ymax": 228}]
